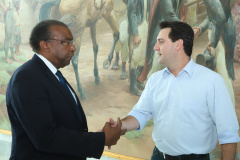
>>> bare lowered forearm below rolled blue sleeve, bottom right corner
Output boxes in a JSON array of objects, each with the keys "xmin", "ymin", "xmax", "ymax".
[{"xmin": 221, "ymin": 143, "xmax": 237, "ymax": 160}]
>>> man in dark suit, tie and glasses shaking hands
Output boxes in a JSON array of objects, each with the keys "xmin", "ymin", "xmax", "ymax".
[{"xmin": 6, "ymin": 20, "xmax": 124, "ymax": 160}]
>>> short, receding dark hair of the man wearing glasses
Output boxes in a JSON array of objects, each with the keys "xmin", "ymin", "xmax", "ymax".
[{"xmin": 29, "ymin": 20, "xmax": 68, "ymax": 52}]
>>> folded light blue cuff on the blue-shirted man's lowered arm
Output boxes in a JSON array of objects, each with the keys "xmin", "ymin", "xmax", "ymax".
[{"xmin": 218, "ymin": 130, "xmax": 240, "ymax": 144}]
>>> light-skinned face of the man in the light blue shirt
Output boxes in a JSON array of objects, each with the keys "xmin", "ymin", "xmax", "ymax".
[{"xmin": 154, "ymin": 28, "xmax": 175, "ymax": 67}]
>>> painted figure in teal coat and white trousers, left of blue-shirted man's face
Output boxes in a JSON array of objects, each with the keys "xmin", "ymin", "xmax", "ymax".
[{"xmin": 127, "ymin": 0, "xmax": 148, "ymax": 96}]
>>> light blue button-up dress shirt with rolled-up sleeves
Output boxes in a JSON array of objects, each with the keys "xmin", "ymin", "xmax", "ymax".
[{"xmin": 129, "ymin": 58, "xmax": 240, "ymax": 156}]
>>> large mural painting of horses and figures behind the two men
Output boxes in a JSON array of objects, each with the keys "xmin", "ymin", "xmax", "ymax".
[{"xmin": 0, "ymin": 0, "xmax": 240, "ymax": 160}]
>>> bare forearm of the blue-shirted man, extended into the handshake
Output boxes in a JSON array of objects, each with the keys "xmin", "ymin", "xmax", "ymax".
[{"xmin": 121, "ymin": 116, "xmax": 140, "ymax": 131}]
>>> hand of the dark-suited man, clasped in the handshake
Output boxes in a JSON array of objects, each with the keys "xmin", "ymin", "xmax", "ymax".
[{"xmin": 103, "ymin": 118, "xmax": 122, "ymax": 146}]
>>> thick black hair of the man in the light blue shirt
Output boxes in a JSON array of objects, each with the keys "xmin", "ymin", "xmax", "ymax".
[{"xmin": 159, "ymin": 21, "xmax": 194, "ymax": 57}]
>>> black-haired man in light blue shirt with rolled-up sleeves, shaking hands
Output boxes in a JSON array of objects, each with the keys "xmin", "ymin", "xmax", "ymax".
[{"xmin": 111, "ymin": 21, "xmax": 240, "ymax": 160}]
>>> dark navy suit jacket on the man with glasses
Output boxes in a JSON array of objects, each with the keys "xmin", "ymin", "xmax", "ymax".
[{"xmin": 6, "ymin": 55, "xmax": 105, "ymax": 160}]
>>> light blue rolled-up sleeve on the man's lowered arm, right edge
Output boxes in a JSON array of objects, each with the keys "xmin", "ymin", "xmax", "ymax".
[{"xmin": 208, "ymin": 75, "xmax": 240, "ymax": 144}]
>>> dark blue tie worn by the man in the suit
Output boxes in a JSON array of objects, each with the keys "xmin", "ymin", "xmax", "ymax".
[{"xmin": 56, "ymin": 70, "xmax": 83, "ymax": 122}]
